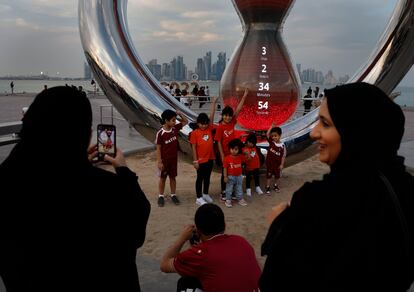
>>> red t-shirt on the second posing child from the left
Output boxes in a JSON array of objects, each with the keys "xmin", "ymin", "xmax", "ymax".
[{"xmin": 190, "ymin": 126, "xmax": 215, "ymax": 163}]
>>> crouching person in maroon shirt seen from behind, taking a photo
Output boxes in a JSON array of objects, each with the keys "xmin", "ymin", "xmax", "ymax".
[{"xmin": 161, "ymin": 204, "xmax": 261, "ymax": 292}]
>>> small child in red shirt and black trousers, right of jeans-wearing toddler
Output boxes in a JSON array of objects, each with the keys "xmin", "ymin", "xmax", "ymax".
[{"xmin": 243, "ymin": 133, "xmax": 263, "ymax": 197}]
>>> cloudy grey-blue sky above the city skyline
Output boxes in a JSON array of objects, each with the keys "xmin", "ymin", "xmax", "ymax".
[{"xmin": 0, "ymin": 0, "xmax": 414, "ymax": 86}]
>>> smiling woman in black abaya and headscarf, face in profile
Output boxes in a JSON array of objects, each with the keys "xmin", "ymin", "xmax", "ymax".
[{"xmin": 260, "ymin": 83, "xmax": 414, "ymax": 292}]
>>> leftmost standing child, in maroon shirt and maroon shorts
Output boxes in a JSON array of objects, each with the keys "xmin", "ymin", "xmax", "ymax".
[{"xmin": 155, "ymin": 109, "xmax": 188, "ymax": 207}]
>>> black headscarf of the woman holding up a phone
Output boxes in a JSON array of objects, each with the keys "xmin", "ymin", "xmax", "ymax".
[{"xmin": 2, "ymin": 86, "xmax": 92, "ymax": 169}]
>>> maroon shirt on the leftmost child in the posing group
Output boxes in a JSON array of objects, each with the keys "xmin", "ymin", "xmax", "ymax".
[{"xmin": 155, "ymin": 123, "xmax": 183, "ymax": 160}]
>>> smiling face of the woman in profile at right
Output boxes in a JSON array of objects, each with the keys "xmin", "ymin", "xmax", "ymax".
[{"xmin": 311, "ymin": 99, "xmax": 341, "ymax": 165}]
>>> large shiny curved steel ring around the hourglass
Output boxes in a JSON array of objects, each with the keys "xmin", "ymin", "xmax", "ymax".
[{"xmin": 79, "ymin": 0, "xmax": 414, "ymax": 164}]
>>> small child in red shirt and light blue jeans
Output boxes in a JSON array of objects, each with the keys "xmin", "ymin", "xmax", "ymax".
[{"xmin": 223, "ymin": 139, "xmax": 247, "ymax": 208}]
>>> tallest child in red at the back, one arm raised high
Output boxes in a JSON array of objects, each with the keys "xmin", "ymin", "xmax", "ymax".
[{"xmin": 214, "ymin": 88, "xmax": 249, "ymax": 201}]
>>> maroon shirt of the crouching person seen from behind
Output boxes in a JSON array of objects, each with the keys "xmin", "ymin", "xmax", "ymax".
[{"xmin": 174, "ymin": 234, "xmax": 261, "ymax": 292}]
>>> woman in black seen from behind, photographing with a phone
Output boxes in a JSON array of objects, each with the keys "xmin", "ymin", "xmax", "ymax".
[{"xmin": 0, "ymin": 86, "xmax": 150, "ymax": 292}]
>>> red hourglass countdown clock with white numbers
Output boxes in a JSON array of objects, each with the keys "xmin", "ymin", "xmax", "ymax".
[{"xmin": 220, "ymin": 0, "xmax": 300, "ymax": 130}]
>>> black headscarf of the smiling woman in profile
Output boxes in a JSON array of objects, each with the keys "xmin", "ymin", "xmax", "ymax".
[{"xmin": 325, "ymin": 82, "xmax": 405, "ymax": 167}]
